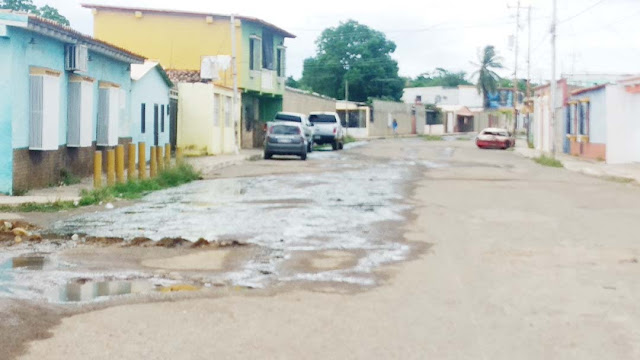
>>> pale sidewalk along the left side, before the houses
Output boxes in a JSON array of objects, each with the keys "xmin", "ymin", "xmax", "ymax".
[{"xmin": 0, "ymin": 149, "xmax": 262, "ymax": 206}]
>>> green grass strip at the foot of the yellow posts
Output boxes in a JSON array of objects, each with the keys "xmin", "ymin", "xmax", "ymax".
[{"xmin": 80, "ymin": 164, "xmax": 200, "ymax": 206}]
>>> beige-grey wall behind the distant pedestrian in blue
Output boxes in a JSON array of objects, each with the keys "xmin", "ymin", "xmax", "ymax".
[{"xmin": 369, "ymin": 100, "xmax": 416, "ymax": 136}]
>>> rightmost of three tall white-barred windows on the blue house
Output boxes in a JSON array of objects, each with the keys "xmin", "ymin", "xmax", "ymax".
[{"xmin": 96, "ymin": 83, "xmax": 120, "ymax": 146}]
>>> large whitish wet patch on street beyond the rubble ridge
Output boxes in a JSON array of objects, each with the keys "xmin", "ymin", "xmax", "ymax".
[{"xmin": 54, "ymin": 159, "xmax": 412, "ymax": 287}]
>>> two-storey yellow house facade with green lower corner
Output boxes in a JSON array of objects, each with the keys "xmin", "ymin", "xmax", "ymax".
[{"xmin": 84, "ymin": 5, "xmax": 294, "ymax": 147}]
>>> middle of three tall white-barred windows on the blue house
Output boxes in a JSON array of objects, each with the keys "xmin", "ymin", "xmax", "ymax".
[{"xmin": 67, "ymin": 76, "xmax": 93, "ymax": 147}]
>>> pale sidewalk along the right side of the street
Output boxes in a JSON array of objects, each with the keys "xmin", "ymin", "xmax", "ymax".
[{"xmin": 515, "ymin": 140, "xmax": 640, "ymax": 183}]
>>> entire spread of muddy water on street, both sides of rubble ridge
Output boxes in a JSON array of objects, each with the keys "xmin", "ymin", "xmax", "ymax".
[{"xmin": 0, "ymin": 142, "xmax": 429, "ymax": 303}]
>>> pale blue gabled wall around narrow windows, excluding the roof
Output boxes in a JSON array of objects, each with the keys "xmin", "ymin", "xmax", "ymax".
[{"xmin": 129, "ymin": 68, "xmax": 171, "ymax": 161}]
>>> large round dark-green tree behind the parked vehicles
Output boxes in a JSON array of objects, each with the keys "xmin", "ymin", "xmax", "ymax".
[{"xmin": 302, "ymin": 20, "xmax": 404, "ymax": 101}]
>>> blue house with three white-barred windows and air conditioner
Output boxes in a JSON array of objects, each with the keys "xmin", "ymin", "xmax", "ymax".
[{"xmin": 0, "ymin": 11, "xmax": 144, "ymax": 194}]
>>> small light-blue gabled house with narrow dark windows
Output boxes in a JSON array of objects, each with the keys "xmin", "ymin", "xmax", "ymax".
[{"xmin": 130, "ymin": 60, "xmax": 175, "ymax": 160}]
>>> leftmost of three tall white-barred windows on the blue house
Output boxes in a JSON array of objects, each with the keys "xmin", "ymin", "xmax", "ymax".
[{"xmin": 29, "ymin": 69, "xmax": 60, "ymax": 150}]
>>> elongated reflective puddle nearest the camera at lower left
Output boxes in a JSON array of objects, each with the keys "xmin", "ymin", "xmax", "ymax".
[{"xmin": 47, "ymin": 281, "xmax": 156, "ymax": 303}]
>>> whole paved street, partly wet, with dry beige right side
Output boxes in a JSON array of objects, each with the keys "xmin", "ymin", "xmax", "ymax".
[{"xmin": 0, "ymin": 138, "xmax": 640, "ymax": 359}]
